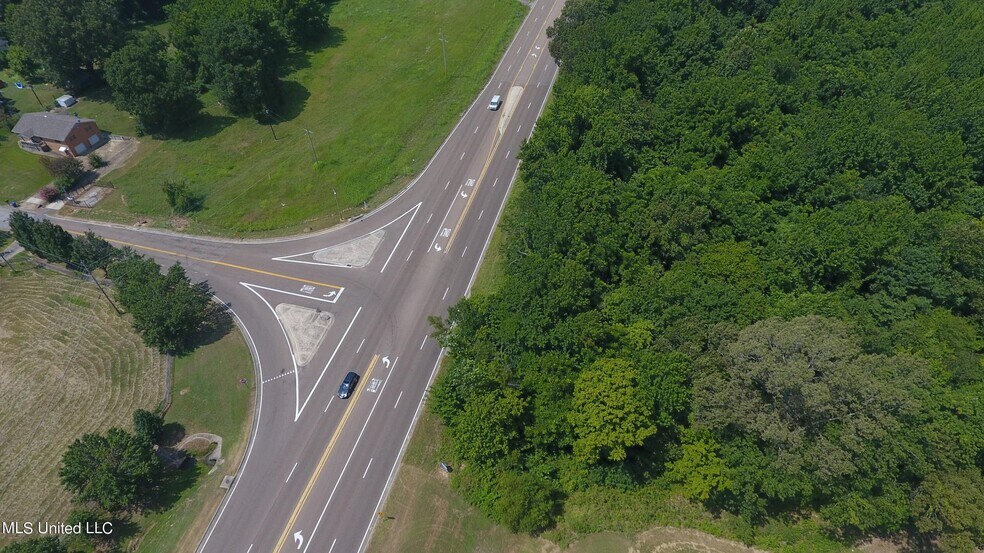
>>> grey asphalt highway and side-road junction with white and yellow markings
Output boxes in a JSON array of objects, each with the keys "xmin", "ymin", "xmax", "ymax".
[{"xmin": 0, "ymin": 0, "xmax": 563, "ymax": 553}]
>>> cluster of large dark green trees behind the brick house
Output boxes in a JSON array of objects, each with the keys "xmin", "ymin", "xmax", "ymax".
[{"xmin": 0, "ymin": 0, "xmax": 329, "ymax": 133}]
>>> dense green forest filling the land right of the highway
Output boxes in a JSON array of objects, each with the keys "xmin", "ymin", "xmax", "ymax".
[{"xmin": 430, "ymin": 0, "xmax": 984, "ymax": 551}]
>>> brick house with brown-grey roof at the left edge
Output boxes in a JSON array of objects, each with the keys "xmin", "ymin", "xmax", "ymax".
[{"xmin": 11, "ymin": 112, "xmax": 103, "ymax": 157}]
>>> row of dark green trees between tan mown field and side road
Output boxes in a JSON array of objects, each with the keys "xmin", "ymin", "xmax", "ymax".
[{"xmin": 10, "ymin": 211, "xmax": 213, "ymax": 354}]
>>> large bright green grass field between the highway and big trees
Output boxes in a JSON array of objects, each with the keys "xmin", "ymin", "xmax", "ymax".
[{"xmin": 91, "ymin": 0, "xmax": 526, "ymax": 234}]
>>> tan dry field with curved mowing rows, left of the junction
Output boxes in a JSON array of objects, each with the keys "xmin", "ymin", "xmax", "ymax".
[{"xmin": 0, "ymin": 269, "xmax": 164, "ymax": 543}]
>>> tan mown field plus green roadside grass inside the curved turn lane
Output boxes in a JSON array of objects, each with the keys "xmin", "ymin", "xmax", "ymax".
[{"xmin": 0, "ymin": 256, "xmax": 253, "ymax": 553}]
